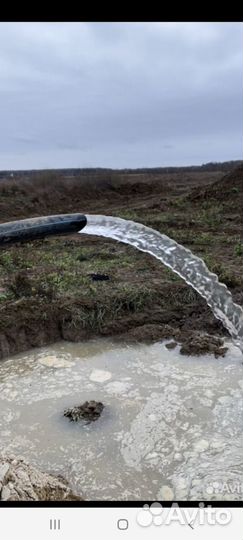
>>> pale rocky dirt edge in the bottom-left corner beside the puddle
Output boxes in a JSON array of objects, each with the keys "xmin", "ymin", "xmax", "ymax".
[{"xmin": 0, "ymin": 455, "xmax": 82, "ymax": 501}]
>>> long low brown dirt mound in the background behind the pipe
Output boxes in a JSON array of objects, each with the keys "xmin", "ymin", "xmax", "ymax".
[{"xmin": 0, "ymin": 172, "xmax": 171, "ymax": 222}]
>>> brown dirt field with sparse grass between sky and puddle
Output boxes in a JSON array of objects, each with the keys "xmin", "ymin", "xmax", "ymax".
[{"xmin": 0, "ymin": 166, "xmax": 243, "ymax": 358}]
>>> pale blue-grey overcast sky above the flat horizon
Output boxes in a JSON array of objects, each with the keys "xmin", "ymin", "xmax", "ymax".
[{"xmin": 0, "ymin": 23, "xmax": 243, "ymax": 169}]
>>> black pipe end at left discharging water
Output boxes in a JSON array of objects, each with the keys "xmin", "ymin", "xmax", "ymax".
[{"xmin": 0, "ymin": 214, "xmax": 87, "ymax": 247}]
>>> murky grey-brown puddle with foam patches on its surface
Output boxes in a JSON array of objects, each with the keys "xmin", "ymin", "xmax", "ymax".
[{"xmin": 0, "ymin": 339, "xmax": 243, "ymax": 500}]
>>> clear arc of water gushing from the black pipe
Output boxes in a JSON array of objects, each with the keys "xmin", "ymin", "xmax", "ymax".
[{"xmin": 80, "ymin": 214, "xmax": 243, "ymax": 351}]
